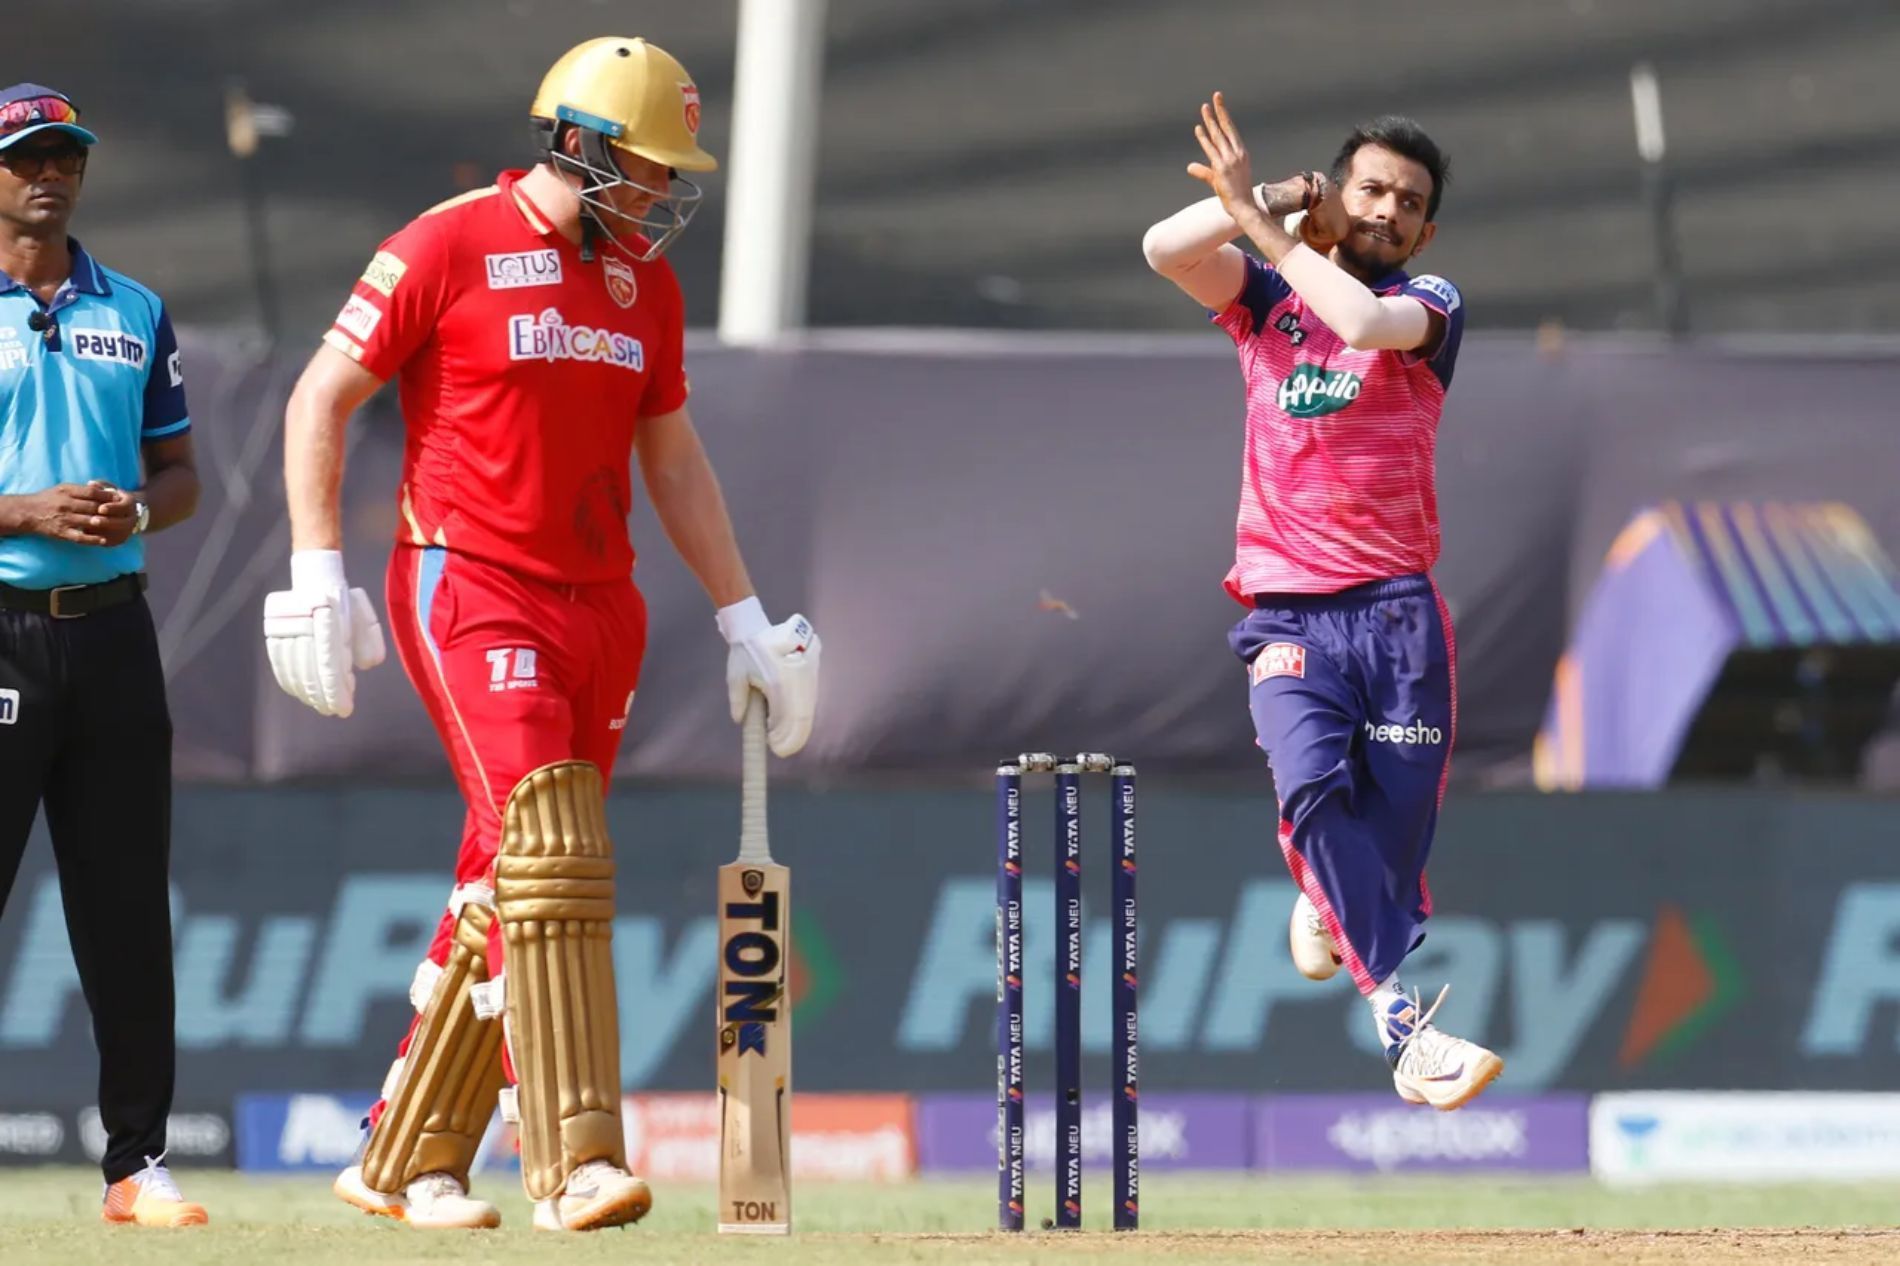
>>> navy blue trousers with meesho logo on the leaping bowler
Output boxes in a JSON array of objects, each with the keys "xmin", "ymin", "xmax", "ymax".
[{"xmin": 1227, "ymin": 576, "xmax": 1457, "ymax": 994}]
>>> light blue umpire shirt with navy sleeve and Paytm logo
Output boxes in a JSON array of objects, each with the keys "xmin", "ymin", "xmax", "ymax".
[{"xmin": 0, "ymin": 240, "xmax": 192, "ymax": 589}]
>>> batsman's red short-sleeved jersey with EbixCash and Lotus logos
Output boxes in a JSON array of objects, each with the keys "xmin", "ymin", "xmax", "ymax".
[{"xmin": 323, "ymin": 171, "xmax": 686, "ymax": 584}]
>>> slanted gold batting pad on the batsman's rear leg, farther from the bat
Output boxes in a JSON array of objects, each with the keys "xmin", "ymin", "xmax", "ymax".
[{"xmin": 363, "ymin": 903, "xmax": 505, "ymax": 1194}]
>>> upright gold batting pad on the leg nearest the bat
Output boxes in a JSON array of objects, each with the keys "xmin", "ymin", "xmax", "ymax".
[{"xmin": 494, "ymin": 760, "xmax": 627, "ymax": 1199}]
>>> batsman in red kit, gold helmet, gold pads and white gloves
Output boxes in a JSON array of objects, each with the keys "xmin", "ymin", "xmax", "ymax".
[{"xmin": 264, "ymin": 38, "xmax": 819, "ymax": 1230}]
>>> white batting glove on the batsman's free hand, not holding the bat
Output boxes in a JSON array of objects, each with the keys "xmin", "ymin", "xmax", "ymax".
[{"xmin": 264, "ymin": 549, "xmax": 384, "ymax": 717}]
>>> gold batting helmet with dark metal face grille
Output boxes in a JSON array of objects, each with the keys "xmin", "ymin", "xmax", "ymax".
[{"xmin": 528, "ymin": 36, "xmax": 718, "ymax": 260}]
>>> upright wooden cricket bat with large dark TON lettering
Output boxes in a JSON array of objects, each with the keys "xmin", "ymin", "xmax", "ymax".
[{"xmin": 718, "ymin": 690, "xmax": 792, "ymax": 1236}]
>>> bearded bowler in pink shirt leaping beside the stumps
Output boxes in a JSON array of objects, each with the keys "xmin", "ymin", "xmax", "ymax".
[{"xmin": 1142, "ymin": 93, "xmax": 1503, "ymax": 1110}]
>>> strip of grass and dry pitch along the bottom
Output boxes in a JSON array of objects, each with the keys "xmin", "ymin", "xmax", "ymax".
[{"xmin": 0, "ymin": 1169, "xmax": 1900, "ymax": 1266}]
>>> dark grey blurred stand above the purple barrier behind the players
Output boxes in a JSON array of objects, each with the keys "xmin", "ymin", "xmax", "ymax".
[{"xmin": 29, "ymin": 0, "xmax": 1900, "ymax": 340}]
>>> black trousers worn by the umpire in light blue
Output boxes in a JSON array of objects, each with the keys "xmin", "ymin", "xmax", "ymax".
[{"xmin": 0, "ymin": 597, "xmax": 177, "ymax": 1182}]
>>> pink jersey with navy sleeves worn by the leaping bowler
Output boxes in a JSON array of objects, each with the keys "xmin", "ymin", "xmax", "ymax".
[{"xmin": 1214, "ymin": 257, "xmax": 1465, "ymax": 603}]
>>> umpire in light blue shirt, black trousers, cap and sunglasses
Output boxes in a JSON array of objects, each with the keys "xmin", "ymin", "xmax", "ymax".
[{"xmin": 0, "ymin": 84, "xmax": 205, "ymax": 1226}]
